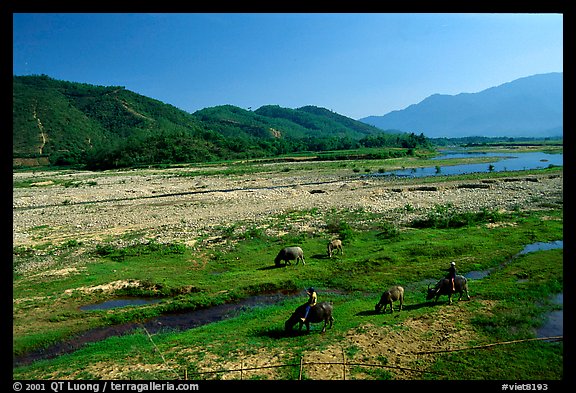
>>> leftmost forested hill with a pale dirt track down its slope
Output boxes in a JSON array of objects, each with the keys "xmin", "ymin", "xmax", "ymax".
[{"xmin": 12, "ymin": 76, "xmax": 212, "ymax": 164}]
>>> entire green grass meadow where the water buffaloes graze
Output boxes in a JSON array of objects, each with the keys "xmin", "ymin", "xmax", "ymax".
[{"xmin": 13, "ymin": 201, "xmax": 563, "ymax": 380}]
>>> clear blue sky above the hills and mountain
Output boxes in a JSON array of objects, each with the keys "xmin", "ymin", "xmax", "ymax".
[{"xmin": 13, "ymin": 13, "xmax": 563, "ymax": 119}]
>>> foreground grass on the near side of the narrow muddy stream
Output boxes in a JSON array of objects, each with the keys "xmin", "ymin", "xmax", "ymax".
[{"xmin": 14, "ymin": 250, "xmax": 563, "ymax": 381}]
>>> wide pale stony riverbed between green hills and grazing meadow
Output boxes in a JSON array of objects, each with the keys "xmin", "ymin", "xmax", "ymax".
[{"xmin": 13, "ymin": 165, "xmax": 563, "ymax": 251}]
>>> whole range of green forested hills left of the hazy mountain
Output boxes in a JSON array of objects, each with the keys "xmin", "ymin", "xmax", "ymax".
[{"xmin": 12, "ymin": 75, "xmax": 428, "ymax": 169}]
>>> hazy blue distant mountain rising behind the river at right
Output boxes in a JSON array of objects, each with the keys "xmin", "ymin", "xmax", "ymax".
[{"xmin": 359, "ymin": 72, "xmax": 563, "ymax": 138}]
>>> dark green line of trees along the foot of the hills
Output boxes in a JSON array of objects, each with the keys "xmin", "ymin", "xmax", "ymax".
[{"xmin": 83, "ymin": 130, "xmax": 430, "ymax": 169}]
